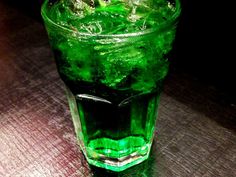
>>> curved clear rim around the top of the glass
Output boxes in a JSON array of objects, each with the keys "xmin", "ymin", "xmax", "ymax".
[{"xmin": 41, "ymin": 0, "xmax": 181, "ymax": 38}]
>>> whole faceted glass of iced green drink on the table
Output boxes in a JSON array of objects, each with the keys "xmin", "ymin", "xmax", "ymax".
[{"xmin": 42, "ymin": 0, "xmax": 180, "ymax": 171}]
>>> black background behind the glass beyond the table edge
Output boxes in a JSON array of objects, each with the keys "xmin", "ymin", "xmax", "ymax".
[{"xmin": 5, "ymin": 0, "xmax": 236, "ymax": 104}]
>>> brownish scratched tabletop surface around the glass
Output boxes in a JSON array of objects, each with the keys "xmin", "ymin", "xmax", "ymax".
[{"xmin": 0, "ymin": 1, "xmax": 236, "ymax": 177}]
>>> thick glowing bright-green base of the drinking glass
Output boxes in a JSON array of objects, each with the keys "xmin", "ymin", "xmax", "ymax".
[{"xmin": 79, "ymin": 137, "xmax": 151, "ymax": 172}]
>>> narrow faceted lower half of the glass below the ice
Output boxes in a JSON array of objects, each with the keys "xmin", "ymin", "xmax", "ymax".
[{"xmin": 67, "ymin": 80, "xmax": 161, "ymax": 171}]
